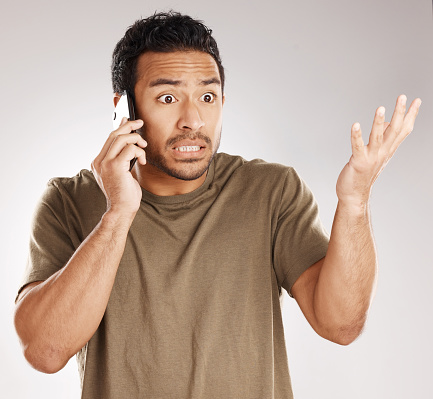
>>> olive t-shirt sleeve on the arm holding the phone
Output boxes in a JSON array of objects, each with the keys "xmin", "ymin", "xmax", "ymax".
[{"xmin": 19, "ymin": 181, "xmax": 75, "ymax": 292}]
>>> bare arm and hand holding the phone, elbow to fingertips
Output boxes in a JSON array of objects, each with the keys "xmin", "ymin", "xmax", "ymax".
[{"xmin": 15, "ymin": 120, "xmax": 146, "ymax": 373}]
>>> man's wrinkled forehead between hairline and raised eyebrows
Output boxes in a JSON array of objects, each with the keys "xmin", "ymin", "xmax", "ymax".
[{"xmin": 137, "ymin": 51, "xmax": 220, "ymax": 86}]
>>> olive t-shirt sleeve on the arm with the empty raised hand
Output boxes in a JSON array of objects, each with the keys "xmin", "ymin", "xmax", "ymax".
[{"xmin": 273, "ymin": 168, "xmax": 329, "ymax": 296}]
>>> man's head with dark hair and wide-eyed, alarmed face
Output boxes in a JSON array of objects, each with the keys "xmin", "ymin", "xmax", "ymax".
[{"xmin": 112, "ymin": 13, "xmax": 224, "ymax": 184}]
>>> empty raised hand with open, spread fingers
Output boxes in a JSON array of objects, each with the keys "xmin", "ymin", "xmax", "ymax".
[{"xmin": 337, "ymin": 94, "xmax": 421, "ymax": 209}]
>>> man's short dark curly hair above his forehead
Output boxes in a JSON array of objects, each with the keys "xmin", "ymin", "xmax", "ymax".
[{"xmin": 111, "ymin": 11, "xmax": 224, "ymax": 96}]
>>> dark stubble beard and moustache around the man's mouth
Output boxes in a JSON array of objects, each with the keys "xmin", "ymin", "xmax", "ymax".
[{"xmin": 145, "ymin": 131, "xmax": 221, "ymax": 181}]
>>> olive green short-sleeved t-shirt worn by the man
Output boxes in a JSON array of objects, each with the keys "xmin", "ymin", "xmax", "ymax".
[{"xmin": 19, "ymin": 153, "xmax": 328, "ymax": 399}]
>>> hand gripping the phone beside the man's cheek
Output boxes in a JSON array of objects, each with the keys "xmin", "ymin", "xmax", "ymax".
[{"xmin": 92, "ymin": 118, "xmax": 147, "ymax": 215}]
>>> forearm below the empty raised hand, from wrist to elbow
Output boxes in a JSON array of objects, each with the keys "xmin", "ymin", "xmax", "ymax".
[{"xmin": 314, "ymin": 201, "xmax": 377, "ymax": 343}]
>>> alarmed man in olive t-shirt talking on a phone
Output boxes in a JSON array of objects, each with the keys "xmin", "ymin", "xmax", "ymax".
[{"xmin": 15, "ymin": 13, "xmax": 421, "ymax": 398}]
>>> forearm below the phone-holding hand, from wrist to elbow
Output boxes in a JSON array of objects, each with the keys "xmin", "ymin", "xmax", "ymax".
[{"xmin": 15, "ymin": 212, "xmax": 132, "ymax": 372}]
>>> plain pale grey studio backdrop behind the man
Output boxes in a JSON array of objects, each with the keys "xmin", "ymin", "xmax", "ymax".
[{"xmin": 0, "ymin": 0, "xmax": 433, "ymax": 399}]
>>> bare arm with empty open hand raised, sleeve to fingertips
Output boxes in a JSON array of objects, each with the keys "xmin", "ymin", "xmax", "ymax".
[{"xmin": 292, "ymin": 95, "xmax": 421, "ymax": 345}]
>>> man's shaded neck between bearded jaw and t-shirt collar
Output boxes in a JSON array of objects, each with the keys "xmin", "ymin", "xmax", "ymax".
[{"xmin": 131, "ymin": 163, "xmax": 207, "ymax": 196}]
